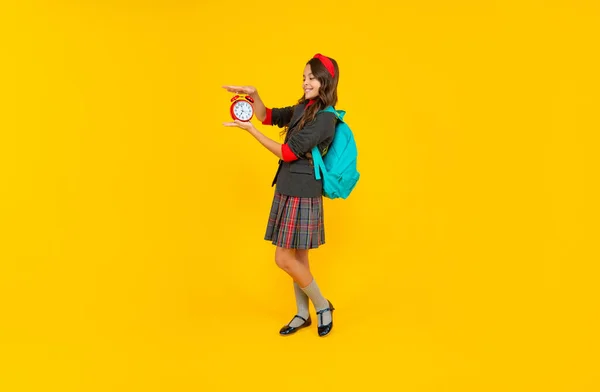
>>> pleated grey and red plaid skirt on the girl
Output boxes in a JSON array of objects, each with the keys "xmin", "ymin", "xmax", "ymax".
[{"xmin": 265, "ymin": 191, "xmax": 325, "ymax": 249}]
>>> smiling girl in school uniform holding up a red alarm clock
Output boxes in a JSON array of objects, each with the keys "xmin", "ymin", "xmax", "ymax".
[{"xmin": 223, "ymin": 54, "xmax": 339, "ymax": 336}]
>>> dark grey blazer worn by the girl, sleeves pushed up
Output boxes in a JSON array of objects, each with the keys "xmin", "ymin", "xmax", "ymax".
[{"xmin": 263, "ymin": 103, "xmax": 337, "ymax": 197}]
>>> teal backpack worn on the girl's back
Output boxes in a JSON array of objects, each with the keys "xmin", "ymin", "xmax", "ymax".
[{"xmin": 311, "ymin": 106, "xmax": 360, "ymax": 199}]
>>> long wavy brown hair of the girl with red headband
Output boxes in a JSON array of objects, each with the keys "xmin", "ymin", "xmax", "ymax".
[{"xmin": 282, "ymin": 57, "xmax": 340, "ymax": 139}]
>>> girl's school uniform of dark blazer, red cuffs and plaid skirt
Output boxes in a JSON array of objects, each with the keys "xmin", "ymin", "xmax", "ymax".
[{"xmin": 263, "ymin": 101, "xmax": 337, "ymax": 249}]
